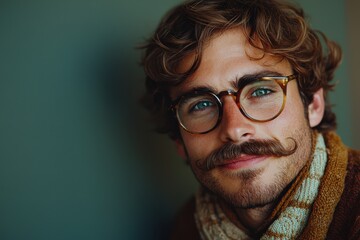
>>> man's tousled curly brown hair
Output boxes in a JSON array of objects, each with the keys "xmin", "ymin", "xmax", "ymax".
[{"xmin": 142, "ymin": 0, "xmax": 341, "ymax": 139}]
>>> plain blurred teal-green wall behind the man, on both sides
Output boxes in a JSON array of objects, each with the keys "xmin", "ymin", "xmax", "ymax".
[{"xmin": 0, "ymin": 0, "xmax": 360, "ymax": 240}]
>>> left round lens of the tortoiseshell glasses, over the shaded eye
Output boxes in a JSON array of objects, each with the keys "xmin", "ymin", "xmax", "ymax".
[{"xmin": 177, "ymin": 93, "xmax": 219, "ymax": 133}]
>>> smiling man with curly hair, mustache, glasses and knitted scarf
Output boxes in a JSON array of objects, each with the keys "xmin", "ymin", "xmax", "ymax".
[{"xmin": 143, "ymin": 0, "xmax": 360, "ymax": 239}]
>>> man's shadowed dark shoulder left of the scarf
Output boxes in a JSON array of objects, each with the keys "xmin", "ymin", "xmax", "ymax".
[{"xmin": 170, "ymin": 196, "xmax": 201, "ymax": 240}]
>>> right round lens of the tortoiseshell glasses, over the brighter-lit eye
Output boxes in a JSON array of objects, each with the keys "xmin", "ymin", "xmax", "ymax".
[{"xmin": 239, "ymin": 80, "xmax": 284, "ymax": 121}]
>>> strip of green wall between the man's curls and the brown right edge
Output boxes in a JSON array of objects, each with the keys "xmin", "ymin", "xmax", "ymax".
[{"xmin": 296, "ymin": 0, "xmax": 352, "ymax": 147}]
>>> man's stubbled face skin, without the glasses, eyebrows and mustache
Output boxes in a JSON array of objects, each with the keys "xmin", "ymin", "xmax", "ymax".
[{"xmin": 170, "ymin": 29, "xmax": 324, "ymax": 207}]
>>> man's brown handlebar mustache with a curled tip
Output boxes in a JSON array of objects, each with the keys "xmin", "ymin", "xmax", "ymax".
[{"xmin": 195, "ymin": 138, "xmax": 298, "ymax": 171}]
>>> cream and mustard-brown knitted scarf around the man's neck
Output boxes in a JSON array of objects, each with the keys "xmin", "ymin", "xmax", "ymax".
[{"xmin": 195, "ymin": 134, "xmax": 347, "ymax": 240}]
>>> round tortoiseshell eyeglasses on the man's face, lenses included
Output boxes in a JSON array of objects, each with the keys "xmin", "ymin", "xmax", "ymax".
[{"xmin": 171, "ymin": 75, "xmax": 296, "ymax": 134}]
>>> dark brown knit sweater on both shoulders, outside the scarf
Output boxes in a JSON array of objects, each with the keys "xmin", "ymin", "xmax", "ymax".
[{"xmin": 171, "ymin": 133, "xmax": 360, "ymax": 240}]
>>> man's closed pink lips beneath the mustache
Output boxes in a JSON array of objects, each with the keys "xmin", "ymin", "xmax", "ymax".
[{"xmin": 217, "ymin": 155, "xmax": 267, "ymax": 170}]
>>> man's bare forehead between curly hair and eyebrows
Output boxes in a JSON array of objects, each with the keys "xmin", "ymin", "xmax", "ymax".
[{"xmin": 170, "ymin": 28, "xmax": 292, "ymax": 99}]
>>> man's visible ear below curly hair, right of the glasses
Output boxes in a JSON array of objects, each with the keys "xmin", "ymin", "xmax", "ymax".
[{"xmin": 308, "ymin": 88, "xmax": 325, "ymax": 127}]
